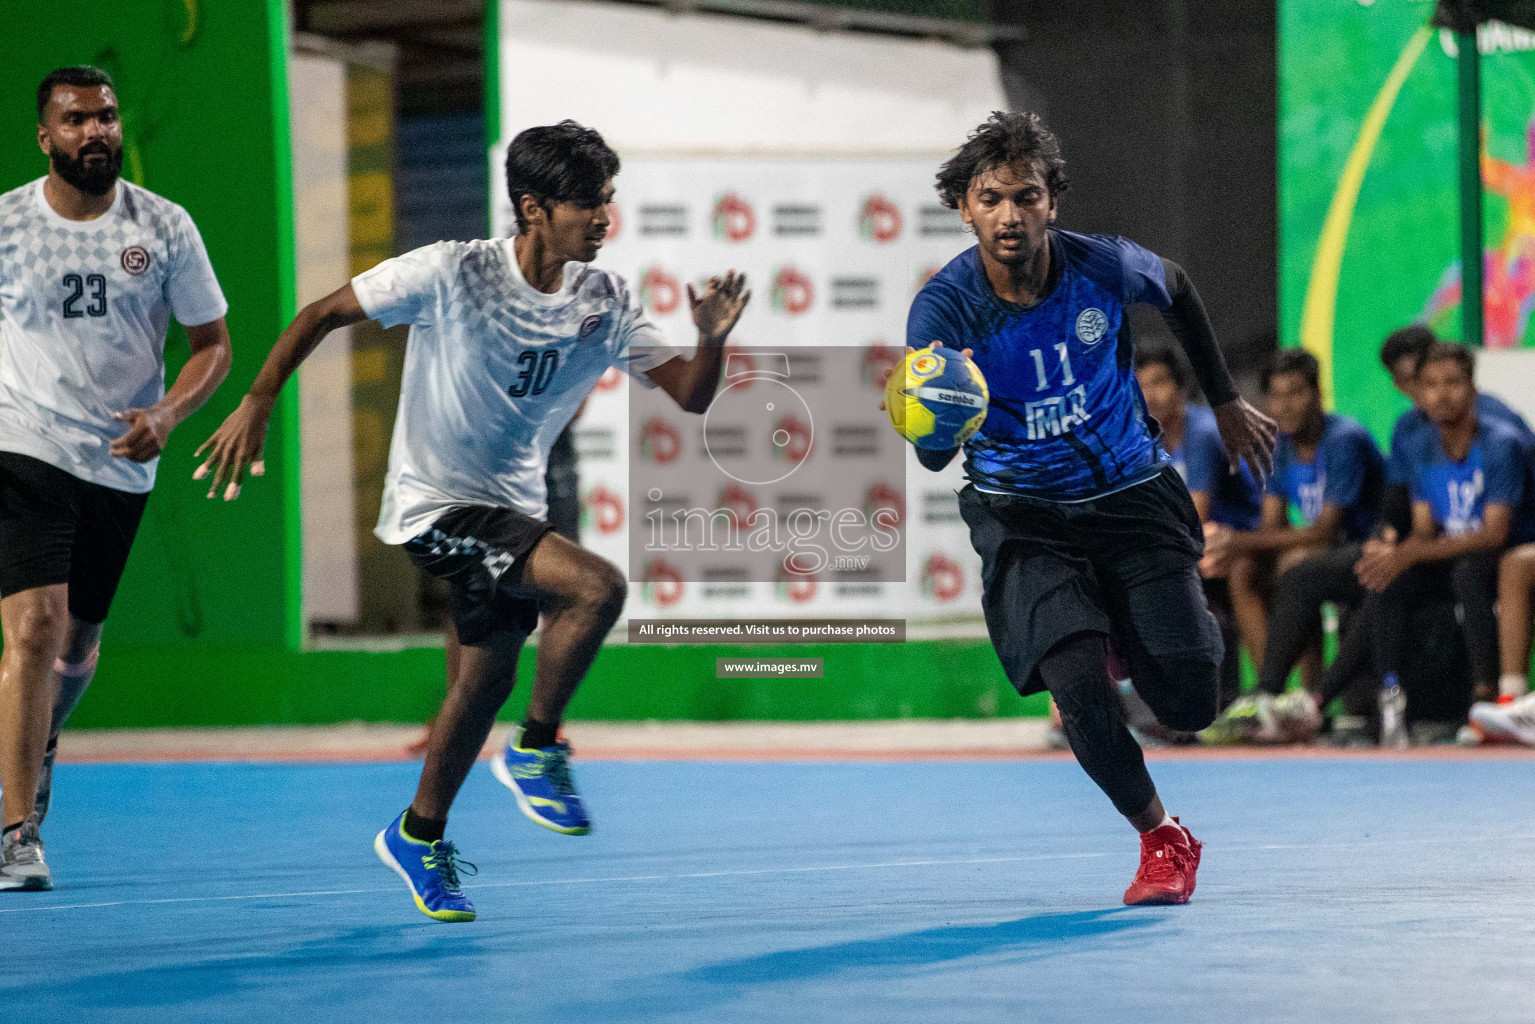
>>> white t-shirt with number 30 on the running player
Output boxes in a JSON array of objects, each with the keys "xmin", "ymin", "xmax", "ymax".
[{"xmin": 352, "ymin": 238, "xmax": 677, "ymax": 543}]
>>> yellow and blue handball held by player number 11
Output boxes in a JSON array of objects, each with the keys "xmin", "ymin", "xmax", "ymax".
[{"xmin": 884, "ymin": 348, "xmax": 990, "ymax": 451}]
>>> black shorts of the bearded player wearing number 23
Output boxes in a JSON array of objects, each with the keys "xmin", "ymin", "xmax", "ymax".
[{"xmin": 0, "ymin": 451, "xmax": 149, "ymax": 622}]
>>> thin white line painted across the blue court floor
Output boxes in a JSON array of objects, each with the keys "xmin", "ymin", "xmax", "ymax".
[{"xmin": 0, "ymin": 835, "xmax": 1535, "ymax": 913}]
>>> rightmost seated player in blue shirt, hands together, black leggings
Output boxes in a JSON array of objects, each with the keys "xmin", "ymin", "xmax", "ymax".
[{"xmin": 1355, "ymin": 342, "xmax": 1535, "ymax": 736}]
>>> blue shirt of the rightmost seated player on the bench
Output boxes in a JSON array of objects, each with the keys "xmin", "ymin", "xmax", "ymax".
[{"xmin": 1406, "ymin": 419, "xmax": 1535, "ymax": 545}]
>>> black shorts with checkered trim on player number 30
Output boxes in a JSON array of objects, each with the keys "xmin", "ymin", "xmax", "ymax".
[{"xmin": 405, "ymin": 505, "xmax": 553, "ymax": 646}]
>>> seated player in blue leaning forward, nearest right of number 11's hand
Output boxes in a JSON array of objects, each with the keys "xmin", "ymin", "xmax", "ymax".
[{"xmin": 1210, "ymin": 348, "xmax": 1385, "ymax": 742}]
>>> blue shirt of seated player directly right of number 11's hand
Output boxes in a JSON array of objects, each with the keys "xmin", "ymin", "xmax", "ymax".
[{"xmin": 1266, "ymin": 413, "xmax": 1386, "ymax": 540}]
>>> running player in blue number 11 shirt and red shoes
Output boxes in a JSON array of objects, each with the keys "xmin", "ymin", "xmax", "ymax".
[{"xmin": 907, "ymin": 114, "xmax": 1273, "ymax": 904}]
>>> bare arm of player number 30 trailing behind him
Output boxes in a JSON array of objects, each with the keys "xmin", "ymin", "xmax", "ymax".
[{"xmin": 194, "ymin": 282, "xmax": 367, "ymax": 502}]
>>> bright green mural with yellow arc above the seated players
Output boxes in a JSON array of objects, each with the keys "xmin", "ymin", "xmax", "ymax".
[{"xmin": 1279, "ymin": 0, "xmax": 1535, "ymax": 438}]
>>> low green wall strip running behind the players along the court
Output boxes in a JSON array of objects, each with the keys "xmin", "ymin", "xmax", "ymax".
[{"xmin": 71, "ymin": 640, "xmax": 1045, "ymax": 728}]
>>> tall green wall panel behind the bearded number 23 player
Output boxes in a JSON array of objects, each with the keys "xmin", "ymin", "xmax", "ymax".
[{"xmin": 0, "ymin": 0, "xmax": 298, "ymax": 654}]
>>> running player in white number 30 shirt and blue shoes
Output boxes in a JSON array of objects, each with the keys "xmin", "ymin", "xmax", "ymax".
[{"xmin": 198, "ymin": 121, "xmax": 751, "ymax": 921}]
